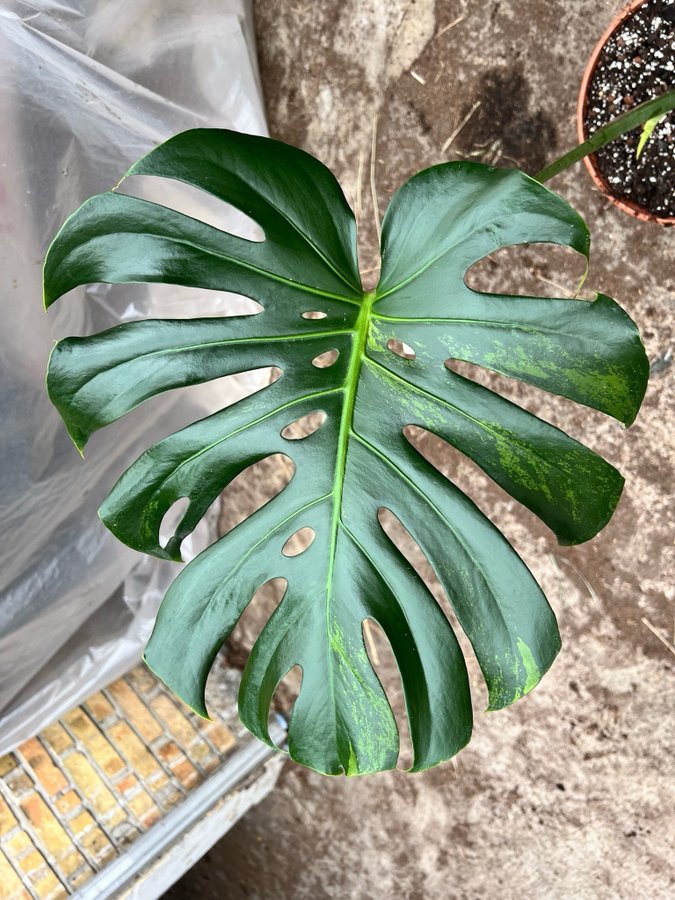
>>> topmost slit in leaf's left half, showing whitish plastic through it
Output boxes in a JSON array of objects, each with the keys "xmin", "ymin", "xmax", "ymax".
[{"xmin": 116, "ymin": 175, "xmax": 265, "ymax": 243}]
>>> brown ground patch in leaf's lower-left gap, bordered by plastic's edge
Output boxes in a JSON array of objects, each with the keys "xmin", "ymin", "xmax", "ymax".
[{"xmin": 218, "ymin": 453, "xmax": 295, "ymax": 535}]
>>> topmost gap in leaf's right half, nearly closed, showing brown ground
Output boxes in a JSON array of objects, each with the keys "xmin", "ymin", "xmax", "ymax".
[{"xmin": 464, "ymin": 244, "xmax": 585, "ymax": 297}]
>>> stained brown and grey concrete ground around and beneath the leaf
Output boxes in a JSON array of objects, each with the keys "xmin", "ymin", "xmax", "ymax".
[{"xmin": 168, "ymin": 0, "xmax": 675, "ymax": 900}]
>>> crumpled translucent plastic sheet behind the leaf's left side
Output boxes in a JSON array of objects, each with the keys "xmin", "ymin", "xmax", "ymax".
[{"xmin": 0, "ymin": 0, "xmax": 265, "ymax": 753}]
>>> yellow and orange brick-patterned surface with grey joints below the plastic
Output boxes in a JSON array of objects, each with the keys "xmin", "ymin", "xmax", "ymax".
[{"xmin": 0, "ymin": 666, "xmax": 237, "ymax": 900}]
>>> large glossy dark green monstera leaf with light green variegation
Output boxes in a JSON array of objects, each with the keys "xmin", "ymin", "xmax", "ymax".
[{"xmin": 45, "ymin": 130, "xmax": 647, "ymax": 774}]
